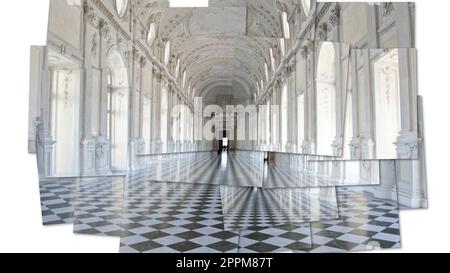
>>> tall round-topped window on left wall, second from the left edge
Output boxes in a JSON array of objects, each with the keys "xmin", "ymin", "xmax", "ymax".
[{"xmin": 107, "ymin": 49, "xmax": 129, "ymax": 171}]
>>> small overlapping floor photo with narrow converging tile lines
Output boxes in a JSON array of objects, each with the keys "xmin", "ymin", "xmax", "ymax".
[{"xmin": 220, "ymin": 186, "xmax": 339, "ymax": 230}]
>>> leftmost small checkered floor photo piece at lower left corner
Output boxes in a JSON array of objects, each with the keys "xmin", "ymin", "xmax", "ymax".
[{"xmin": 39, "ymin": 179, "xmax": 77, "ymax": 225}]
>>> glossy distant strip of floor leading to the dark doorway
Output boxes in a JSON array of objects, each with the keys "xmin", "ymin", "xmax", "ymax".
[{"xmin": 143, "ymin": 150, "xmax": 379, "ymax": 188}]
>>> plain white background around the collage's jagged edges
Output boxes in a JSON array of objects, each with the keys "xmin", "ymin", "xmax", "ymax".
[{"xmin": 0, "ymin": 0, "xmax": 450, "ymax": 253}]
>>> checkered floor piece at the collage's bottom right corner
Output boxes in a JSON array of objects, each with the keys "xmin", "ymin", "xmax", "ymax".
[{"xmin": 311, "ymin": 187, "xmax": 400, "ymax": 253}]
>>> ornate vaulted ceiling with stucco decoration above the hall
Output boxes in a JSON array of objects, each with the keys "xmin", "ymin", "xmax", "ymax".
[{"xmin": 135, "ymin": 0, "xmax": 300, "ymax": 102}]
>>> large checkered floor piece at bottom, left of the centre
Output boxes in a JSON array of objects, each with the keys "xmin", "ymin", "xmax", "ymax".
[{"xmin": 120, "ymin": 181, "xmax": 239, "ymax": 253}]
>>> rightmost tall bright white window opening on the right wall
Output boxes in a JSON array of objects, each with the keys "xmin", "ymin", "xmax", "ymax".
[{"xmin": 374, "ymin": 50, "xmax": 400, "ymax": 158}]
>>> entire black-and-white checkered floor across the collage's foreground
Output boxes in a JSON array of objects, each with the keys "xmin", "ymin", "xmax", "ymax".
[{"xmin": 36, "ymin": 150, "xmax": 400, "ymax": 253}]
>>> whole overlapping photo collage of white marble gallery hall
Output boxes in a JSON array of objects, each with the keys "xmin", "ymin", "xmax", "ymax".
[{"xmin": 28, "ymin": 0, "xmax": 428, "ymax": 253}]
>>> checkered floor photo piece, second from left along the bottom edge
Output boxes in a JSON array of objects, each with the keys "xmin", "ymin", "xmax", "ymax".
[{"xmin": 74, "ymin": 177, "xmax": 125, "ymax": 237}]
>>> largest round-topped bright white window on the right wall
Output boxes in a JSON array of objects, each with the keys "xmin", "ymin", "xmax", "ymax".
[{"xmin": 316, "ymin": 42, "xmax": 336, "ymax": 155}]
